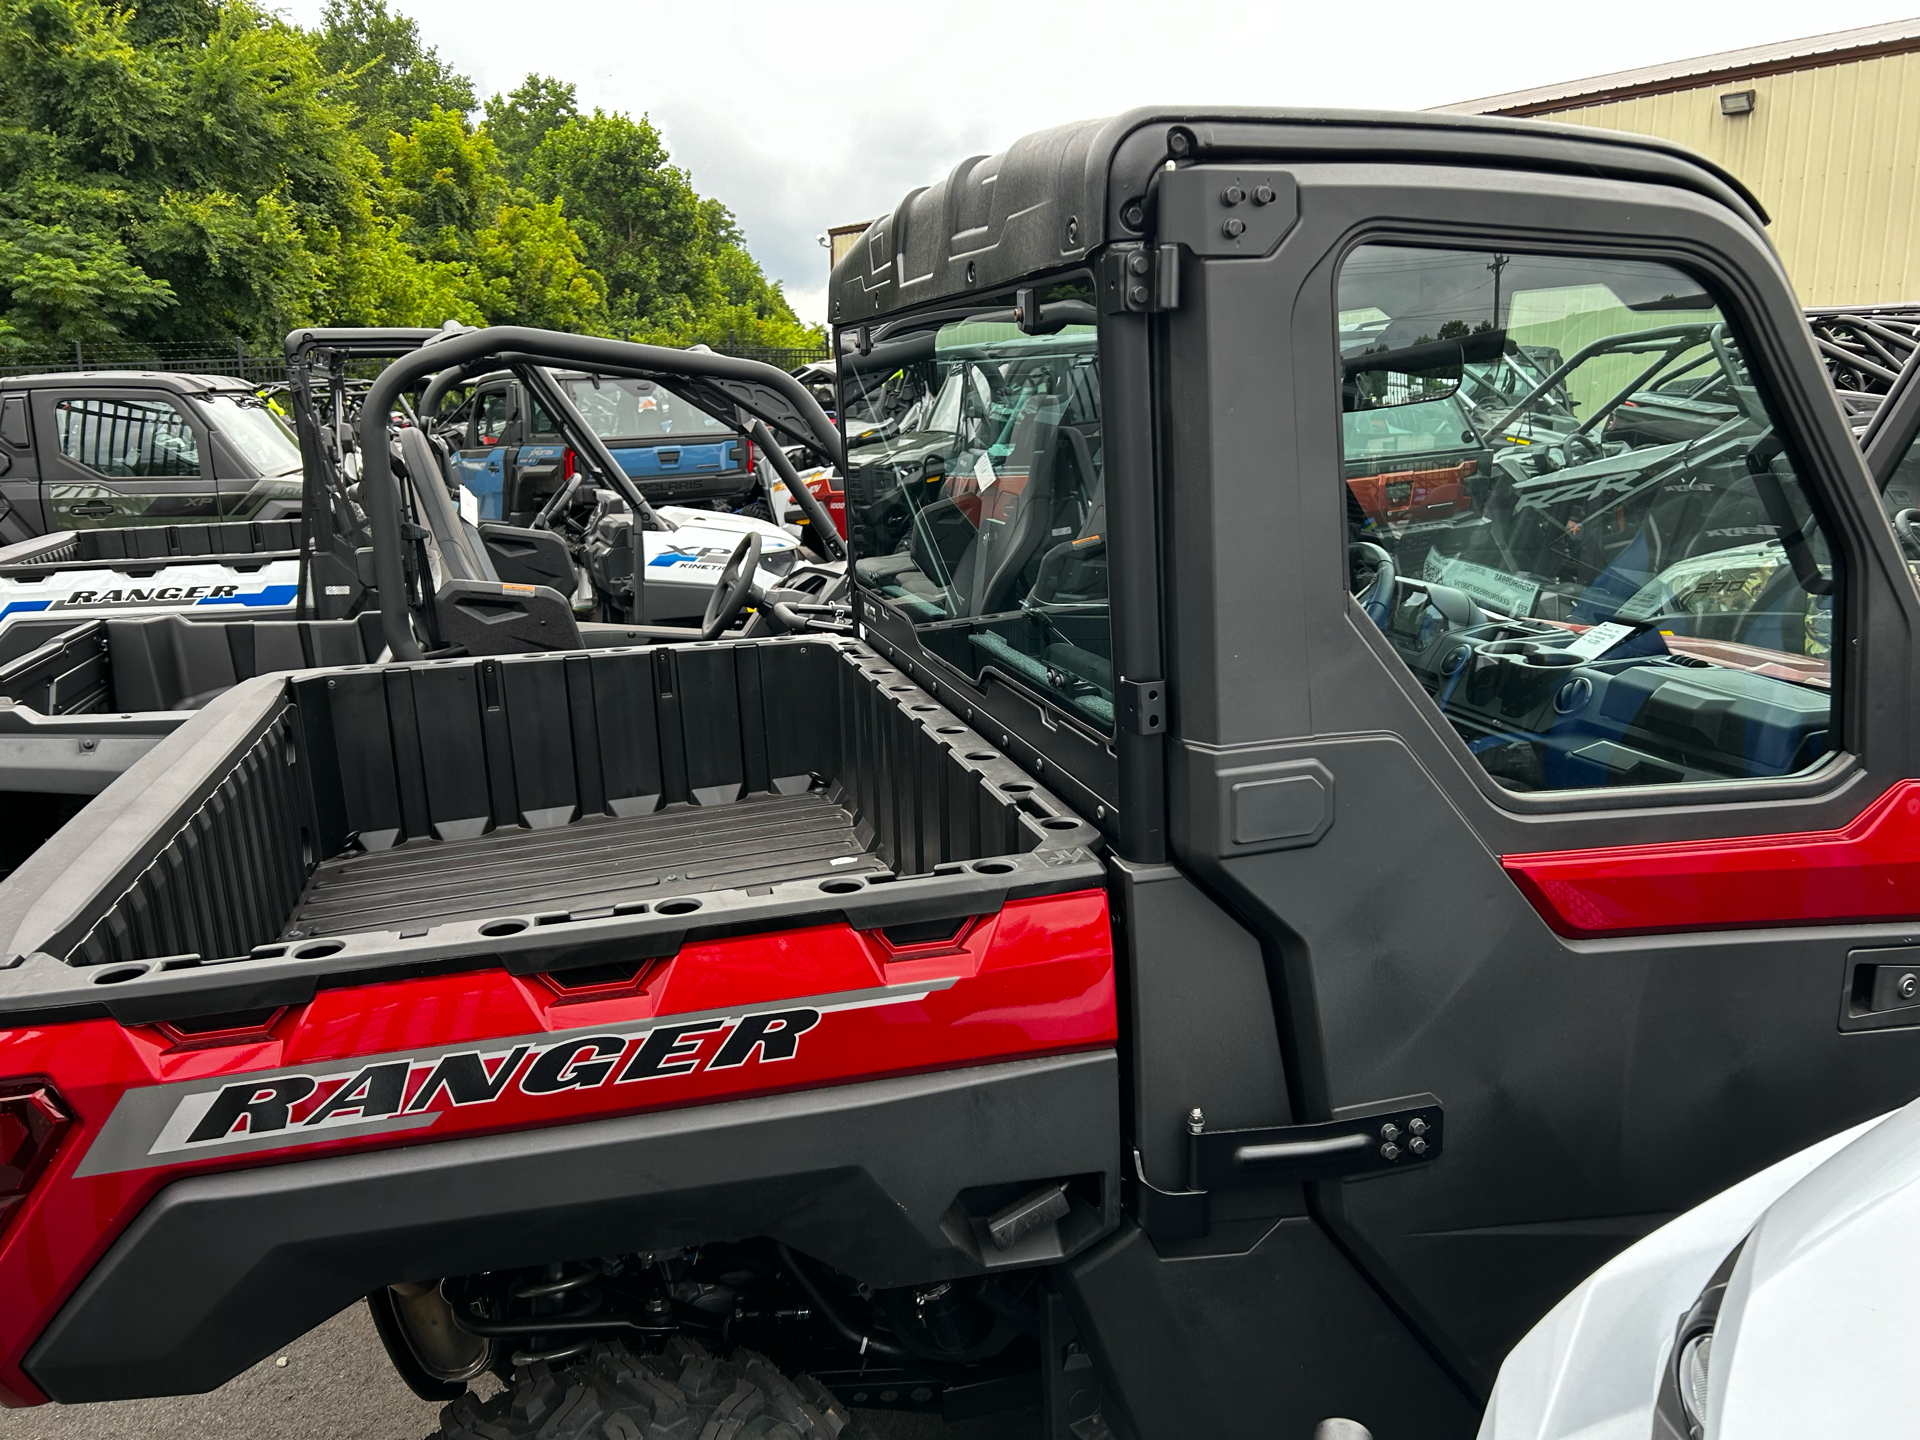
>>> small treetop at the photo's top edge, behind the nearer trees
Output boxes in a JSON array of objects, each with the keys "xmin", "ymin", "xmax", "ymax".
[{"xmin": 309, "ymin": 0, "xmax": 474, "ymax": 146}]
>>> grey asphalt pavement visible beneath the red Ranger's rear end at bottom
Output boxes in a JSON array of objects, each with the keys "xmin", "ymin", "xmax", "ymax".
[{"xmin": 0, "ymin": 1306, "xmax": 1039, "ymax": 1440}]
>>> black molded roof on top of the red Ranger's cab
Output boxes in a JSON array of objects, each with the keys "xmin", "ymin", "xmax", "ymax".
[{"xmin": 828, "ymin": 108, "xmax": 1766, "ymax": 324}]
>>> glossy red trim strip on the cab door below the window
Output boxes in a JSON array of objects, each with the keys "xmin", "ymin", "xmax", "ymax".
[{"xmin": 1501, "ymin": 780, "xmax": 1920, "ymax": 937}]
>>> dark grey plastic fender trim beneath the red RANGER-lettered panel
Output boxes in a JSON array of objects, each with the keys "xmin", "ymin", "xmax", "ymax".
[{"xmin": 25, "ymin": 1050, "xmax": 1119, "ymax": 1402}]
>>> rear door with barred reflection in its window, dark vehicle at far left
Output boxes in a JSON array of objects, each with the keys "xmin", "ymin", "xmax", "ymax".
[{"xmin": 33, "ymin": 384, "xmax": 219, "ymax": 530}]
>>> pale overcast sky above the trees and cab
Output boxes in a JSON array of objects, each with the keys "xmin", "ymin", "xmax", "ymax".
[{"xmin": 286, "ymin": 0, "xmax": 1920, "ymax": 321}]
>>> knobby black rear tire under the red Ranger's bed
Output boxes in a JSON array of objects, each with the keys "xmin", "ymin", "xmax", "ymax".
[{"xmin": 430, "ymin": 1336, "xmax": 870, "ymax": 1440}]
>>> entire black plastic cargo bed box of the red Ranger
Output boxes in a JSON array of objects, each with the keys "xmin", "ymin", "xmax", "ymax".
[{"xmin": 0, "ymin": 637, "xmax": 1104, "ymax": 1023}]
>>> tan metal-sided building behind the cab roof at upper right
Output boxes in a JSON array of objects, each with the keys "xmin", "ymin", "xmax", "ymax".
[{"xmin": 1440, "ymin": 19, "xmax": 1920, "ymax": 305}]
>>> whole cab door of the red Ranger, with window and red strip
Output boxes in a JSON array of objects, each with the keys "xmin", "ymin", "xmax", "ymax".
[{"xmin": 1160, "ymin": 163, "xmax": 1920, "ymax": 1405}]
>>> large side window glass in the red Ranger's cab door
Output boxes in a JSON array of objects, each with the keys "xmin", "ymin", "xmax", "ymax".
[{"xmin": 1338, "ymin": 246, "xmax": 1841, "ymax": 791}]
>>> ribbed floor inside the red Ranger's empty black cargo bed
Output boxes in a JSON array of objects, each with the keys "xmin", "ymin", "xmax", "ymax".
[{"xmin": 282, "ymin": 791, "xmax": 887, "ymax": 941}]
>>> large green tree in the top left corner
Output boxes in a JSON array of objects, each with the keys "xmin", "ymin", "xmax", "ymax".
[{"xmin": 0, "ymin": 0, "xmax": 374, "ymax": 346}]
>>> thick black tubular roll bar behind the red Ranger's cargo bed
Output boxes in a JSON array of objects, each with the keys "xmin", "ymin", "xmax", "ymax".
[{"xmin": 359, "ymin": 324, "xmax": 845, "ymax": 660}]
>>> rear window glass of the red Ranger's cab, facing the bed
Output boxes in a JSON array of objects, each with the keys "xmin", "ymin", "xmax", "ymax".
[{"xmin": 839, "ymin": 282, "xmax": 1114, "ymax": 732}]
